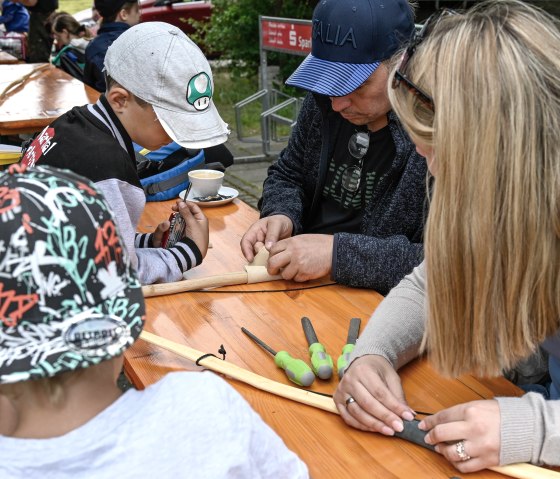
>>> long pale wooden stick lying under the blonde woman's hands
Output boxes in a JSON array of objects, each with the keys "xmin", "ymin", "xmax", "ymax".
[{"xmin": 140, "ymin": 331, "xmax": 560, "ymax": 479}]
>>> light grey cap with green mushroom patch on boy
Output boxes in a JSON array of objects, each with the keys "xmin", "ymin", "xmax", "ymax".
[{"xmin": 105, "ymin": 22, "xmax": 229, "ymax": 149}]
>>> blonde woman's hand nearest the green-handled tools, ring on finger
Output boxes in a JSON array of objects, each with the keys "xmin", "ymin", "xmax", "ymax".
[{"xmin": 334, "ymin": 355, "xmax": 414, "ymax": 436}]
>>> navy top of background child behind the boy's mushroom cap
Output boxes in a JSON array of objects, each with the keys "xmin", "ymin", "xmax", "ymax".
[{"xmin": 84, "ymin": 22, "xmax": 130, "ymax": 92}]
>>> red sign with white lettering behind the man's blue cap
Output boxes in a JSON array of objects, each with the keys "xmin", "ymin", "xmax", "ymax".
[{"xmin": 261, "ymin": 19, "xmax": 311, "ymax": 55}]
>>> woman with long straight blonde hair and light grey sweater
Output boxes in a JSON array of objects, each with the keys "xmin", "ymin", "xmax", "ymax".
[{"xmin": 335, "ymin": 0, "xmax": 560, "ymax": 472}]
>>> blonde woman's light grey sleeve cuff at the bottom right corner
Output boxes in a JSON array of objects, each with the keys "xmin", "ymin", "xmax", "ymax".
[{"xmin": 496, "ymin": 393, "xmax": 560, "ymax": 466}]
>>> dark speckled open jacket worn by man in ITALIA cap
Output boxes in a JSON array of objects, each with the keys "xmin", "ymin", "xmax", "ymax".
[{"xmin": 259, "ymin": 94, "xmax": 428, "ymax": 294}]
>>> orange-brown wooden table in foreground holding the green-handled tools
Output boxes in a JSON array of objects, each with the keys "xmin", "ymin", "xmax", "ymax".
[{"xmin": 125, "ymin": 200, "xmax": 520, "ymax": 479}]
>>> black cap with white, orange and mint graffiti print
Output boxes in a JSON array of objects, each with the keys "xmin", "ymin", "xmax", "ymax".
[{"xmin": 0, "ymin": 165, "xmax": 145, "ymax": 384}]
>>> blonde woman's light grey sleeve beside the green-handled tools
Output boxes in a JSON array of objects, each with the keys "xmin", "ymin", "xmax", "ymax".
[{"xmin": 350, "ymin": 262, "xmax": 426, "ymax": 369}]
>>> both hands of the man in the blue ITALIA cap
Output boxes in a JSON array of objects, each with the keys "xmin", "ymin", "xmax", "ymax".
[{"xmin": 241, "ymin": 215, "xmax": 333, "ymax": 281}]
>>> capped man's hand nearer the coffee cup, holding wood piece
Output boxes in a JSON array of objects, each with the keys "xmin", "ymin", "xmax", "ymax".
[{"xmin": 241, "ymin": 215, "xmax": 294, "ymax": 263}]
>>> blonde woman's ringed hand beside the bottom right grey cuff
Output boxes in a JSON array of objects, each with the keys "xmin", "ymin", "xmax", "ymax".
[{"xmin": 418, "ymin": 399, "xmax": 500, "ymax": 472}]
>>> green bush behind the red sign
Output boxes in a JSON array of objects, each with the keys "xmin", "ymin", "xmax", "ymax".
[{"xmin": 193, "ymin": 0, "xmax": 317, "ymax": 79}]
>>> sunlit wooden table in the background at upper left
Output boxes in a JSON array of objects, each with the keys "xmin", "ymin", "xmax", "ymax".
[{"xmin": 0, "ymin": 63, "xmax": 99, "ymax": 136}]
